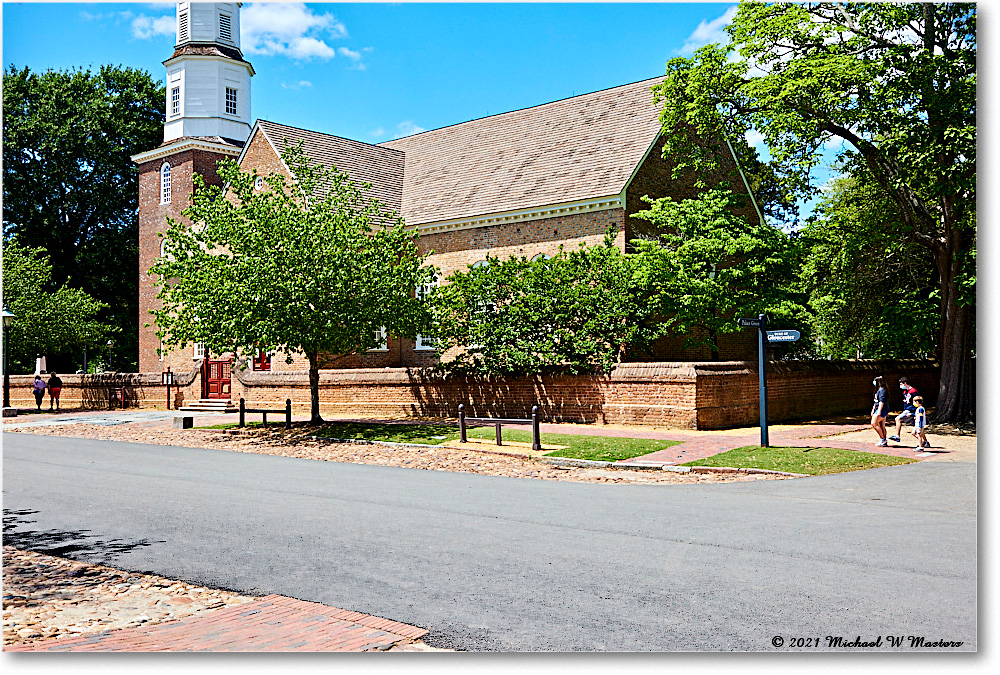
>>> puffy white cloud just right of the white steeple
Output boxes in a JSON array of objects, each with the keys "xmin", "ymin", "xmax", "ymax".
[{"xmin": 240, "ymin": 2, "xmax": 347, "ymax": 61}]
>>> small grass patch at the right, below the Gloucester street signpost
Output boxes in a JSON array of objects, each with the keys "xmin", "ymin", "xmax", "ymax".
[{"xmin": 681, "ymin": 445, "xmax": 916, "ymax": 476}]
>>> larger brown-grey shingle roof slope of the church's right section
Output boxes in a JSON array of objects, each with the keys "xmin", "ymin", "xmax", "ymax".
[{"xmin": 380, "ymin": 77, "xmax": 663, "ymax": 225}]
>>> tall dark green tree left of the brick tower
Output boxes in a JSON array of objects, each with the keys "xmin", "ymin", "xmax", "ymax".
[{"xmin": 3, "ymin": 66, "xmax": 164, "ymax": 370}]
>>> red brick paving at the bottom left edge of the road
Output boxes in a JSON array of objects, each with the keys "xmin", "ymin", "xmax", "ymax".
[{"xmin": 4, "ymin": 595, "xmax": 427, "ymax": 652}]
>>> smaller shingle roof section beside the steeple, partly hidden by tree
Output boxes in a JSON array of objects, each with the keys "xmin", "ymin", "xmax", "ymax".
[{"xmin": 257, "ymin": 120, "xmax": 403, "ymax": 218}]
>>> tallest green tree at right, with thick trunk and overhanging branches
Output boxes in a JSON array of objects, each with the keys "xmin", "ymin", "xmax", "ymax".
[{"xmin": 656, "ymin": 3, "xmax": 976, "ymax": 421}]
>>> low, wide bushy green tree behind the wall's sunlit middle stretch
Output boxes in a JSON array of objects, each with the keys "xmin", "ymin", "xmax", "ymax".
[{"xmin": 433, "ymin": 231, "xmax": 662, "ymax": 375}]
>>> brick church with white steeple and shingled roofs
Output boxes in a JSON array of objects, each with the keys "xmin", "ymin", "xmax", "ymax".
[{"xmin": 132, "ymin": 2, "xmax": 750, "ymax": 399}]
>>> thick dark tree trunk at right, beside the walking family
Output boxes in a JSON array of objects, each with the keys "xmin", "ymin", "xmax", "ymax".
[{"xmin": 933, "ymin": 233, "xmax": 976, "ymax": 424}]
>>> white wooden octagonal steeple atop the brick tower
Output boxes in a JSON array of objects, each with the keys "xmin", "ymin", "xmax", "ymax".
[{"xmin": 163, "ymin": 2, "xmax": 254, "ymax": 143}]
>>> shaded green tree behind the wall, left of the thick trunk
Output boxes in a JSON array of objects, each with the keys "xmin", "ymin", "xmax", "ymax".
[{"xmin": 800, "ymin": 173, "xmax": 941, "ymax": 358}]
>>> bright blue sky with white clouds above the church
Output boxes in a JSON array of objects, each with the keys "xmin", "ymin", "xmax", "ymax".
[{"xmin": 3, "ymin": 2, "xmax": 836, "ymax": 222}]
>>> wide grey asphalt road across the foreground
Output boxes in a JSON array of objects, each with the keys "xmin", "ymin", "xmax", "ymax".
[{"xmin": 3, "ymin": 433, "xmax": 977, "ymax": 651}]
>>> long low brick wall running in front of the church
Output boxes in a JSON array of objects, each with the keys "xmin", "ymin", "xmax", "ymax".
[{"xmin": 11, "ymin": 361, "xmax": 938, "ymax": 429}]
